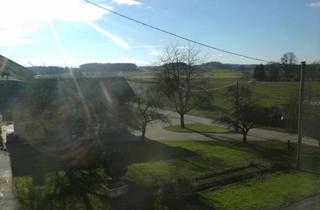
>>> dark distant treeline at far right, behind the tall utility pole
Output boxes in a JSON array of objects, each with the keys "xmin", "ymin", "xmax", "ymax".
[{"xmin": 252, "ymin": 63, "xmax": 320, "ymax": 82}]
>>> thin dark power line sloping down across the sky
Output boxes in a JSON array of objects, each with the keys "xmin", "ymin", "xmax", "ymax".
[{"xmin": 83, "ymin": 0, "xmax": 273, "ymax": 63}]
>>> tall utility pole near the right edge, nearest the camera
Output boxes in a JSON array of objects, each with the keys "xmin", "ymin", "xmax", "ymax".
[{"xmin": 296, "ymin": 61, "xmax": 306, "ymax": 169}]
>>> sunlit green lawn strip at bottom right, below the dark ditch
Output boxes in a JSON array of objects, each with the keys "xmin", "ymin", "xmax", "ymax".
[{"xmin": 201, "ymin": 172, "xmax": 320, "ymax": 210}]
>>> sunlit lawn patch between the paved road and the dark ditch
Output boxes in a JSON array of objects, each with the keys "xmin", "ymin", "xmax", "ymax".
[{"xmin": 126, "ymin": 141, "xmax": 270, "ymax": 186}]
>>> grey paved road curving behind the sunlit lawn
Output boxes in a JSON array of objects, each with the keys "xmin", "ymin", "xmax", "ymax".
[{"xmin": 136, "ymin": 111, "xmax": 318, "ymax": 146}]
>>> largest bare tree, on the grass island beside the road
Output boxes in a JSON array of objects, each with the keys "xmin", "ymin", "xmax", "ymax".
[{"xmin": 157, "ymin": 45, "xmax": 210, "ymax": 128}]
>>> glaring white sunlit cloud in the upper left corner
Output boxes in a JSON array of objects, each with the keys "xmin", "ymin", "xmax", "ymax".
[{"xmin": 0, "ymin": 0, "xmax": 111, "ymax": 46}]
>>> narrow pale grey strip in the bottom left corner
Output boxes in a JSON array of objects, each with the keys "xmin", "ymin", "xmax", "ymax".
[{"xmin": 0, "ymin": 150, "xmax": 19, "ymax": 210}]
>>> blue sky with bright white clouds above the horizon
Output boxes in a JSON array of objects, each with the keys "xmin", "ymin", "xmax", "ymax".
[{"xmin": 0, "ymin": 0, "xmax": 320, "ymax": 67}]
